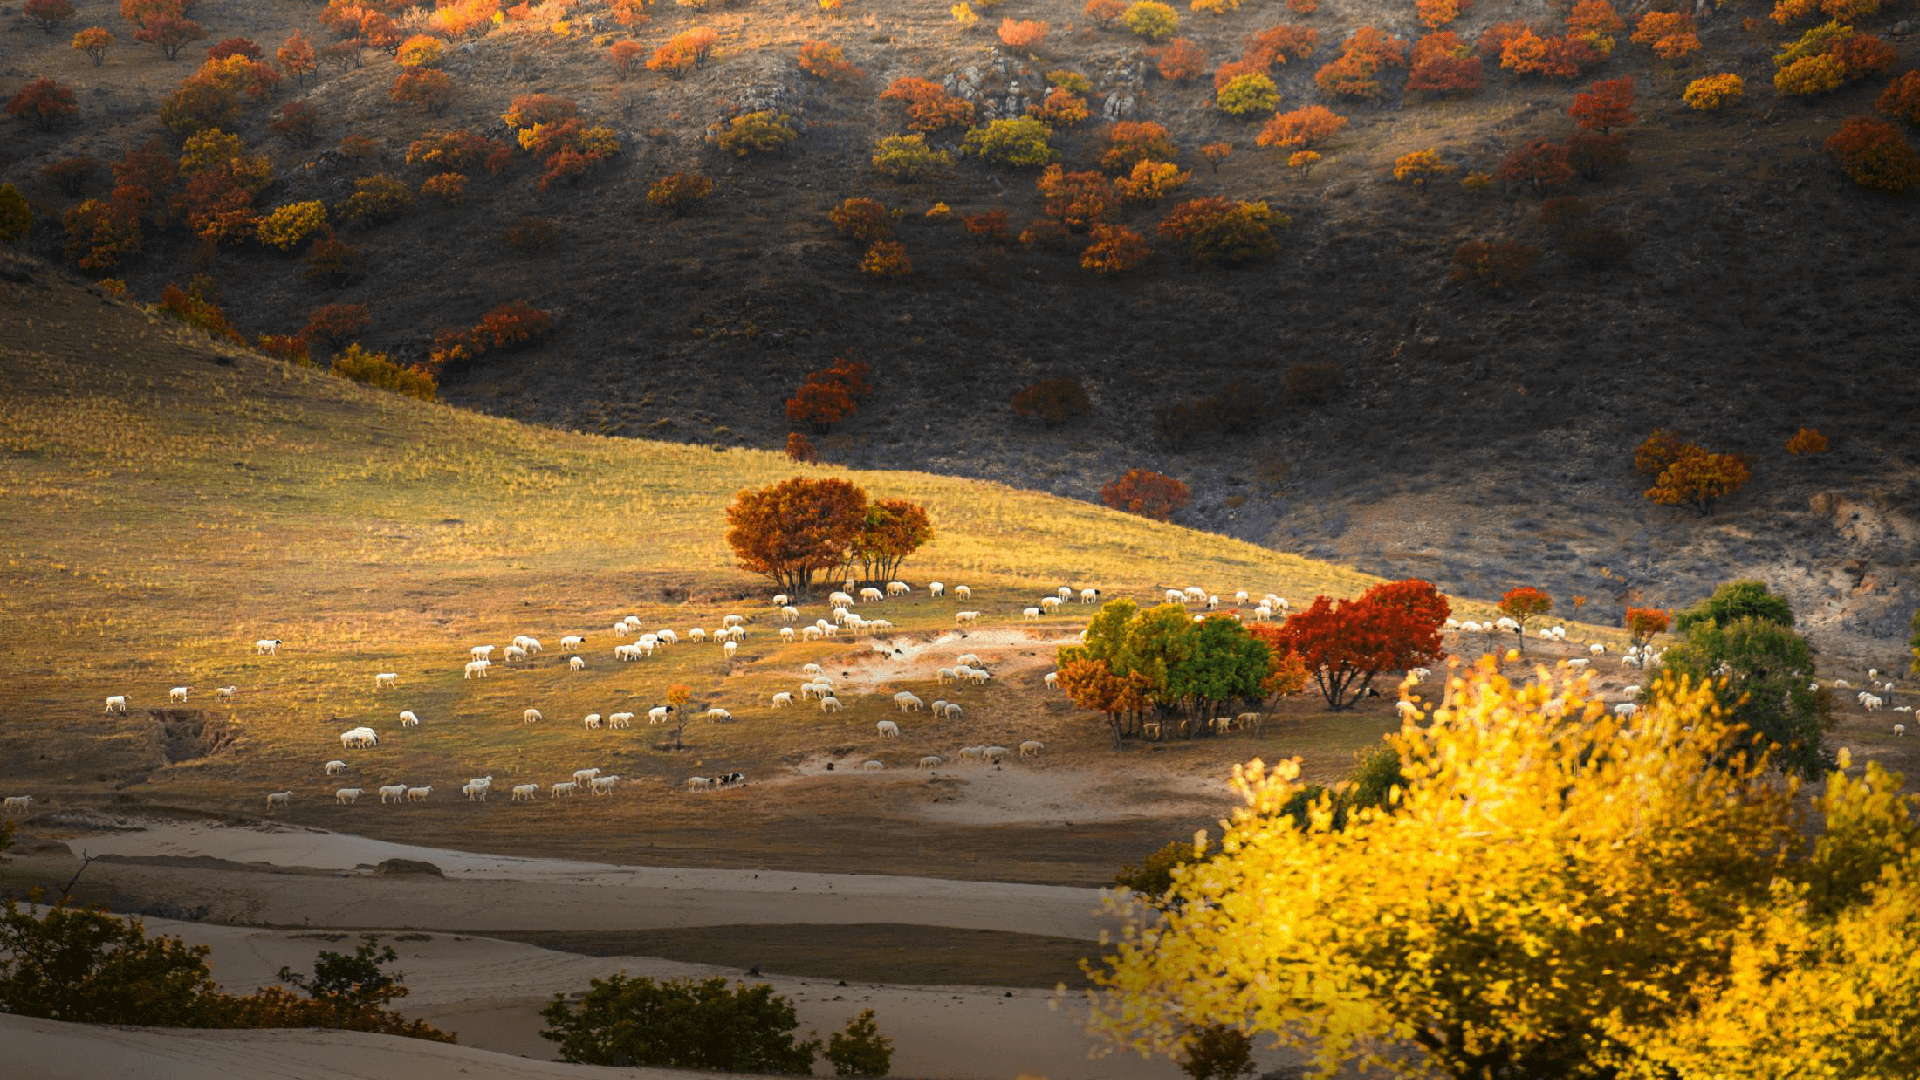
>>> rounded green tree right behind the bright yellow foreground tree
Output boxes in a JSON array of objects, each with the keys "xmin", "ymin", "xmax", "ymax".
[{"xmin": 1661, "ymin": 615, "xmax": 1834, "ymax": 778}]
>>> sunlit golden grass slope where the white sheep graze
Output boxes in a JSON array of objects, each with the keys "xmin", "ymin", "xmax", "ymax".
[{"xmin": 0, "ymin": 261, "xmax": 1912, "ymax": 882}]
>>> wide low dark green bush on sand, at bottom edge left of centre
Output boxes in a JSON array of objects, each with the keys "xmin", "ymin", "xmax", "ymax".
[{"xmin": 540, "ymin": 974, "xmax": 820, "ymax": 1074}]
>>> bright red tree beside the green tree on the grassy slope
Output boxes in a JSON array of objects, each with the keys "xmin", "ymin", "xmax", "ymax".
[{"xmin": 1279, "ymin": 580, "xmax": 1452, "ymax": 711}]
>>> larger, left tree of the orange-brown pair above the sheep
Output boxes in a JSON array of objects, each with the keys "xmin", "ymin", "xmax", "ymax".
[{"xmin": 726, "ymin": 477, "xmax": 868, "ymax": 596}]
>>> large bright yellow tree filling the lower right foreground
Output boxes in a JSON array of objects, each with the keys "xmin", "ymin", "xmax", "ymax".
[{"xmin": 1091, "ymin": 661, "xmax": 1920, "ymax": 1080}]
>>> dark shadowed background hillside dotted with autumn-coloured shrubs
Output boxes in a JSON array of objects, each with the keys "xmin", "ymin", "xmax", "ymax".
[{"xmin": 0, "ymin": 0, "xmax": 1920, "ymax": 667}]
